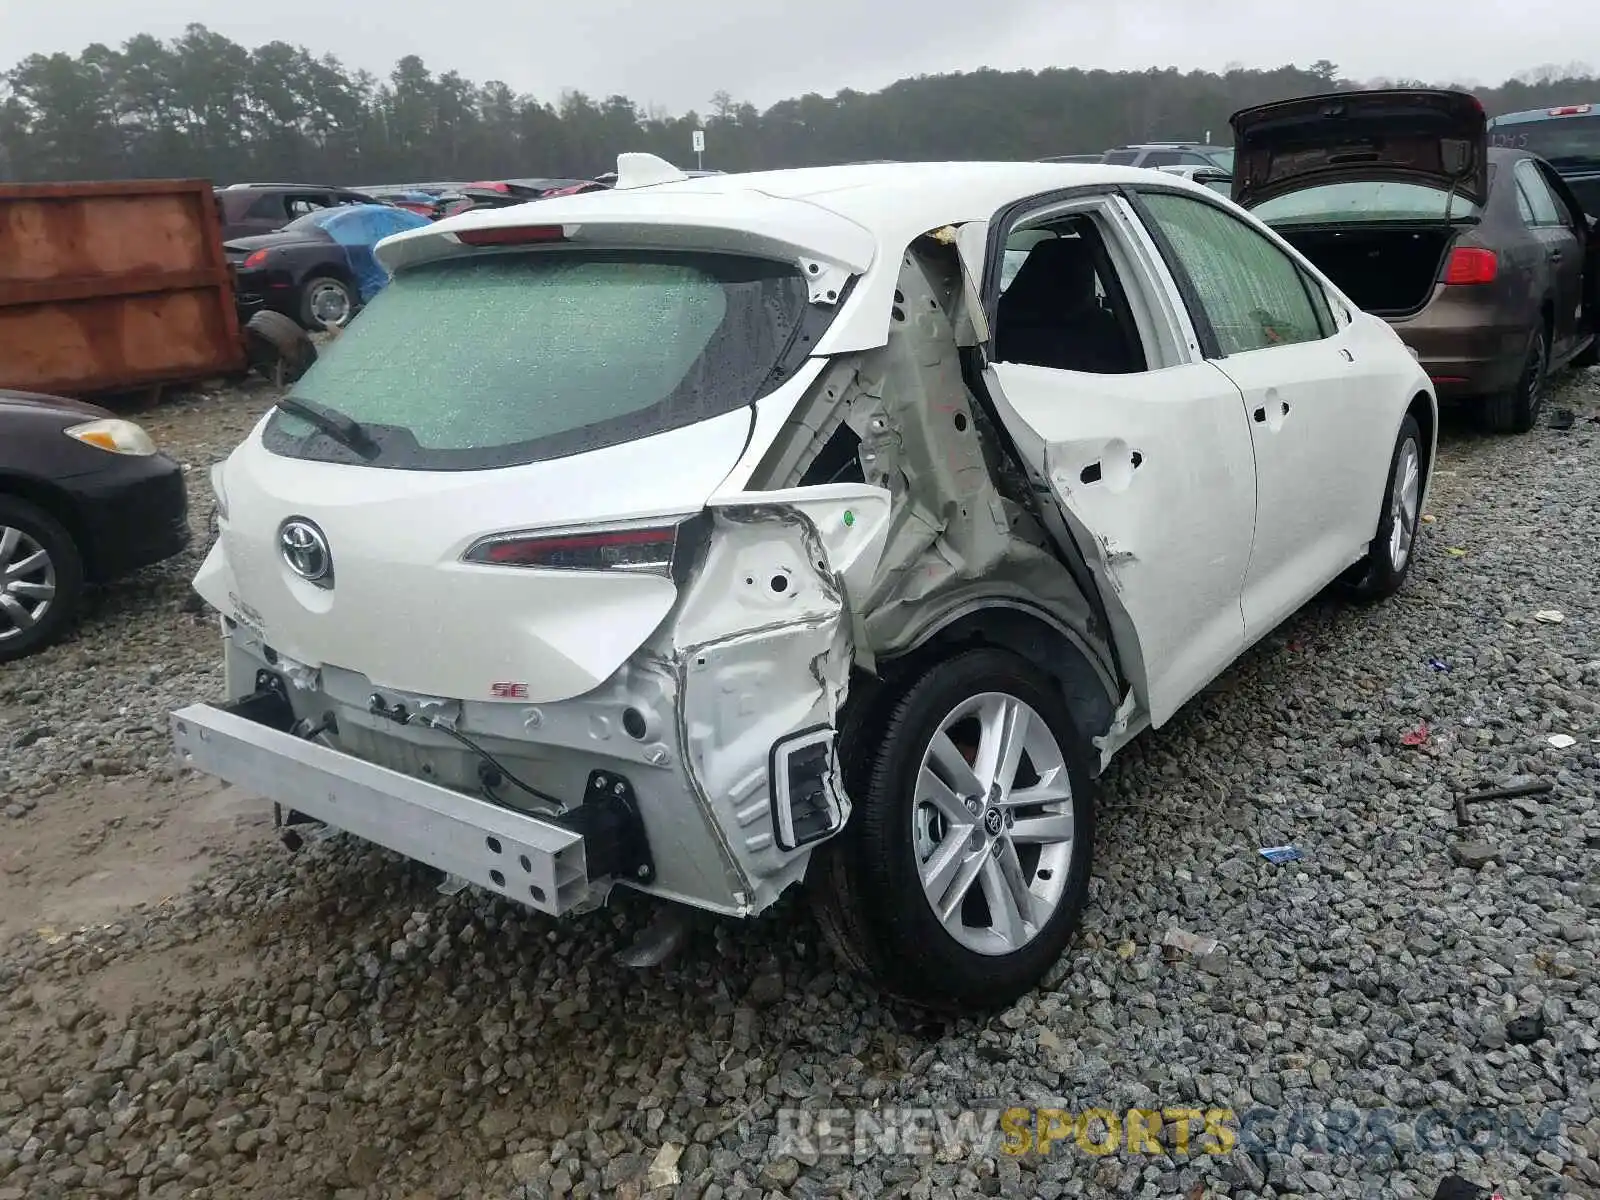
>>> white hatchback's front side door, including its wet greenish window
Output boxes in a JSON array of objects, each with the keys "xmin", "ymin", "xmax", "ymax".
[{"xmin": 1138, "ymin": 187, "xmax": 1395, "ymax": 642}]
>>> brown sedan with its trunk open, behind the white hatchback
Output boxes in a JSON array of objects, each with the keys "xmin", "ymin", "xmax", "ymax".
[{"xmin": 1232, "ymin": 90, "xmax": 1600, "ymax": 432}]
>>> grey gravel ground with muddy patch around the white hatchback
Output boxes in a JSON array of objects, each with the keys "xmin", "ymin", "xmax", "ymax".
[{"xmin": 0, "ymin": 371, "xmax": 1600, "ymax": 1200}]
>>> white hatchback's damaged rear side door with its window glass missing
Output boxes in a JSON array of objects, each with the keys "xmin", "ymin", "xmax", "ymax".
[{"xmin": 963, "ymin": 194, "xmax": 1256, "ymax": 726}]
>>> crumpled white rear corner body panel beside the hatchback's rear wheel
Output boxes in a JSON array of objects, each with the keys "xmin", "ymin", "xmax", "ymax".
[{"xmin": 670, "ymin": 485, "xmax": 890, "ymax": 912}]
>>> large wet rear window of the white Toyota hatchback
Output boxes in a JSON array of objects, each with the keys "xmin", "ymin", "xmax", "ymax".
[{"xmin": 262, "ymin": 248, "xmax": 834, "ymax": 470}]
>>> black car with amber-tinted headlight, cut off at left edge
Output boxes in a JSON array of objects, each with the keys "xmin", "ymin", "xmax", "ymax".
[{"xmin": 0, "ymin": 390, "xmax": 189, "ymax": 662}]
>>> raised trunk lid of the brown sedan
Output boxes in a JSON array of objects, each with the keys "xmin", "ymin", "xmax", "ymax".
[{"xmin": 1229, "ymin": 88, "xmax": 1490, "ymax": 208}]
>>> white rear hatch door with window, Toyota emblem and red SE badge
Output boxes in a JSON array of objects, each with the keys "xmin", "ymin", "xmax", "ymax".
[{"xmin": 206, "ymin": 197, "xmax": 876, "ymax": 702}]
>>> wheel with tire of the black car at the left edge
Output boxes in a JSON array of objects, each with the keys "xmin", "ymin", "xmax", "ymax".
[{"xmin": 0, "ymin": 496, "xmax": 83, "ymax": 662}]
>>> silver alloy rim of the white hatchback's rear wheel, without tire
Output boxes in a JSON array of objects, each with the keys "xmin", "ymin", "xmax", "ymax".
[{"xmin": 912, "ymin": 691, "xmax": 1077, "ymax": 955}]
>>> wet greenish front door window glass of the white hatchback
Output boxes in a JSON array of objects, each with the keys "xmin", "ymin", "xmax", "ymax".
[{"xmin": 1144, "ymin": 192, "xmax": 1326, "ymax": 355}]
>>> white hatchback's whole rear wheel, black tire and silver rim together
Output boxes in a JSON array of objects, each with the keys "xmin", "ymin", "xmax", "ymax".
[{"xmin": 810, "ymin": 646, "xmax": 1094, "ymax": 1011}]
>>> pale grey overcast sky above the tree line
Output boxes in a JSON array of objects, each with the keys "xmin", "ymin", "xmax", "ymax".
[{"xmin": 0, "ymin": 0, "xmax": 1600, "ymax": 112}]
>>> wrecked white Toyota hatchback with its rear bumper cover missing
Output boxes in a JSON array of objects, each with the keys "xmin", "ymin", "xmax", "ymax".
[{"xmin": 173, "ymin": 155, "xmax": 1435, "ymax": 1008}]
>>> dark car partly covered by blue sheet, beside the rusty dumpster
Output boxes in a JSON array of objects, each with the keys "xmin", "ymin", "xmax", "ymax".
[{"xmin": 222, "ymin": 205, "xmax": 430, "ymax": 330}]
